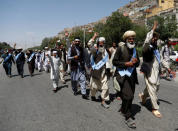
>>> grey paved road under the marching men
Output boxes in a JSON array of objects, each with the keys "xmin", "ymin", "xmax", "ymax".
[{"xmin": 0, "ymin": 63, "xmax": 178, "ymax": 131}]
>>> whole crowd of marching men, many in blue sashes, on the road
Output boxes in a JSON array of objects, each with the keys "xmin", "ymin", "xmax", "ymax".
[{"xmin": 2, "ymin": 22, "xmax": 175, "ymax": 128}]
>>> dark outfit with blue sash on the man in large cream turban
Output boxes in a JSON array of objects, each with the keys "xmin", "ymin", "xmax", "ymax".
[{"xmin": 113, "ymin": 44, "xmax": 140, "ymax": 119}]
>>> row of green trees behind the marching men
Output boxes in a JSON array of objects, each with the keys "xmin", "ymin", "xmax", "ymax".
[{"xmin": 38, "ymin": 11, "xmax": 178, "ymax": 50}]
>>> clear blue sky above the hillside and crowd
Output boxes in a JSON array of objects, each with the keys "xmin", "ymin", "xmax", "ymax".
[{"xmin": 0, "ymin": 0, "xmax": 131, "ymax": 48}]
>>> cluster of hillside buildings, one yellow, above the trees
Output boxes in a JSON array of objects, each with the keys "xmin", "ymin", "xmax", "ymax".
[{"xmin": 118, "ymin": 0, "xmax": 178, "ymax": 25}]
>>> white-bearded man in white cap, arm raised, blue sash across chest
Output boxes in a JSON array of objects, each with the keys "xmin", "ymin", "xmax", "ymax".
[{"xmin": 88, "ymin": 33, "xmax": 111, "ymax": 108}]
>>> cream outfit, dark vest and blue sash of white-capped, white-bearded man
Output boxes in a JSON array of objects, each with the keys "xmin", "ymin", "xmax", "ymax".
[{"xmin": 88, "ymin": 39, "xmax": 111, "ymax": 101}]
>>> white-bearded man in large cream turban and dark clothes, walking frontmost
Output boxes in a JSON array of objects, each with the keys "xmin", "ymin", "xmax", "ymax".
[{"xmin": 113, "ymin": 31, "xmax": 140, "ymax": 128}]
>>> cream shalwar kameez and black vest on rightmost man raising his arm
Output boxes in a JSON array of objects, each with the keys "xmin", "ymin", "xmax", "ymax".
[{"xmin": 141, "ymin": 30, "xmax": 161, "ymax": 110}]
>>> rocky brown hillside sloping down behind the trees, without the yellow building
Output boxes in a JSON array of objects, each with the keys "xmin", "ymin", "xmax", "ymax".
[{"xmin": 57, "ymin": 0, "xmax": 157, "ymax": 39}]
